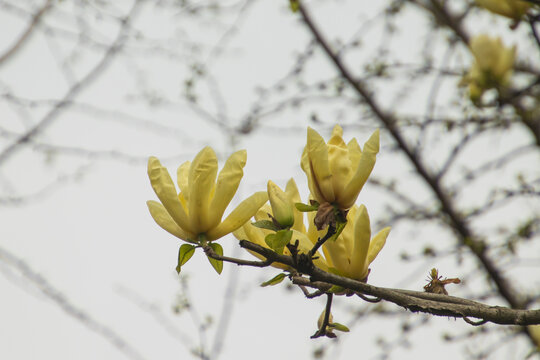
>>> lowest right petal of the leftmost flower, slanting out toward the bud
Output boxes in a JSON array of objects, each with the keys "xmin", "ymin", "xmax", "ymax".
[{"xmin": 206, "ymin": 191, "xmax": 268, "ymax": 240}]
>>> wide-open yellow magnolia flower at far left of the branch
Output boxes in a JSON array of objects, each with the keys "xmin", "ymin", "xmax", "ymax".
[{"xmin": 147, "ymin": 147, "xmax": 268, "ymax": 243}]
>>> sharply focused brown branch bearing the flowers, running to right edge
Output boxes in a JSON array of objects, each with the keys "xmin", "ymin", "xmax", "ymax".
[{"xmin": 240, "ymin": 240, "xmax": 540, "ymax": 325}]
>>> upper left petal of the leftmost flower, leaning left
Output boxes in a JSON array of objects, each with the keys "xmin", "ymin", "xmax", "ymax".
[{"xmin": 148, "ymin": 156, "xmax": 195, "ymax": 233}]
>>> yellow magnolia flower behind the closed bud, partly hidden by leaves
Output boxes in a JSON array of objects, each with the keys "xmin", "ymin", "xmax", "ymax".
[{"xmin": 233, "ymin": 179, "xmax": 327, "ymax": 270}]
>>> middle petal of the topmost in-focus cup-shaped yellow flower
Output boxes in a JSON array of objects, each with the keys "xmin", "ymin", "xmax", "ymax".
[{"xmin": 328, "ymin": 129, "xmax": 352, "ymax": 202}]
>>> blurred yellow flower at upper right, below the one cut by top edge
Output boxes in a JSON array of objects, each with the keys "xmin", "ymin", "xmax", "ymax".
[{"xmin": 463, "ymin": 35, "xmax": 516, "ymax": 101}]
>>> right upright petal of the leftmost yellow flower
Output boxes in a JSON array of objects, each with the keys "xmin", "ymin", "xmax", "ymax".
[{"xmin": 210, "ymin": 150, "xmax": 247, "ymax": 228}]
